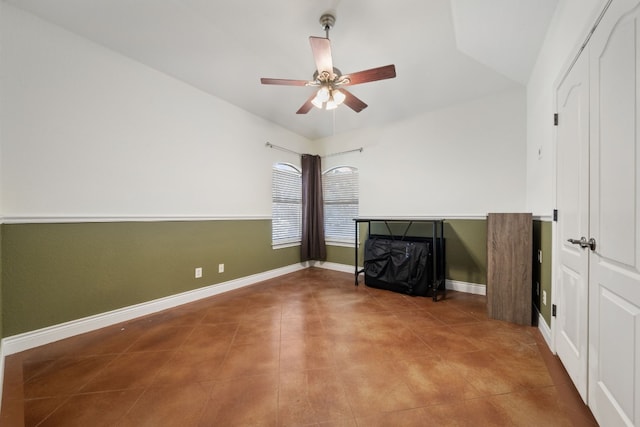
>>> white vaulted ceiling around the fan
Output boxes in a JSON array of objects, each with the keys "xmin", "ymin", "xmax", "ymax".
[{"xmin": 7, "ymin": 0, "xmax": 559, "ymax": 140}]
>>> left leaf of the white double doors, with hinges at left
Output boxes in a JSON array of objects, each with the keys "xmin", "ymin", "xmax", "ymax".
[{"xmin": 553, "ymin": 52, "xmax": 589, "ymax": 402}]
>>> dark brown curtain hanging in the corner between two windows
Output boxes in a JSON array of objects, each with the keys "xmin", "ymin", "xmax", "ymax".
[{"xmin": 300, "ymin": 154, "xmax": 327, "ymax": 261}]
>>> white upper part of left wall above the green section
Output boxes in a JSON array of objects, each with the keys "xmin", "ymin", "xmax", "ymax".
[{"xmin": 0, "ymin": 2, "xmax": 311, "ymax": 219}]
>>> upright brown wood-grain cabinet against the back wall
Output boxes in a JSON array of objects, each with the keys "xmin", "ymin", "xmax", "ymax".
[{"xmin": 487, "ymin": 213, "xmax": 533, "ymax": 325}]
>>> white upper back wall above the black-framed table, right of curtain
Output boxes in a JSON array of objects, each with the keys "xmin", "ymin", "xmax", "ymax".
[{"xmin": 314, "ymin": 88, "xmax": 526, "ymax": 217}]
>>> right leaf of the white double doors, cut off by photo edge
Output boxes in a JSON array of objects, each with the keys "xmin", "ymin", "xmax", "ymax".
[{"xmin": 588, "ymin": 0, "xmax": 640, "ymax": 426}]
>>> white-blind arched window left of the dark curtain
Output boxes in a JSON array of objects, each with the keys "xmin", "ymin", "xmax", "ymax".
[{"xmin": 271, "ymin": 163, "xmax": 302, "ymax": 246}]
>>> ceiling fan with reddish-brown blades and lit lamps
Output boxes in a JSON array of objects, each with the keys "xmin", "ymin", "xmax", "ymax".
[{"xmin": 260, "ymin": 13, "xmax": 396, "ymax": 114}]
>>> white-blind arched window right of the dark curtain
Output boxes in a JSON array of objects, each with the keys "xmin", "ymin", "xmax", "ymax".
[{"xmin": 322, "ymin": 166, "xmax": 359, "ymax": 243}]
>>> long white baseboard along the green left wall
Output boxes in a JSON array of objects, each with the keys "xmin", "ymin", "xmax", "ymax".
[{"xmin": 0, "ymin": 264, "xmax": 306, "ymax": 358}]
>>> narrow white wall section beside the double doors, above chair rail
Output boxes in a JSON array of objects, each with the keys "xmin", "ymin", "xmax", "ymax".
[{"xmin": 527, "ymin": 0, "xmax": 607, "ymax": 216}]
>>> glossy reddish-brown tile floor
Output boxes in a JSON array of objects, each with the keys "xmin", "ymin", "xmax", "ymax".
[{"xmin": 0, "ymin": 268, "xmax": 597, "ymax": 427}]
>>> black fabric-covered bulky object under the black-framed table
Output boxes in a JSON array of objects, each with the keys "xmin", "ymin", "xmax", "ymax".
[{"xmin": 364, "ymin": 236, "xmax": 444, "ymax": 296}]
